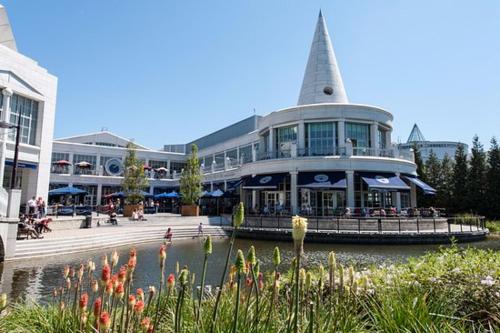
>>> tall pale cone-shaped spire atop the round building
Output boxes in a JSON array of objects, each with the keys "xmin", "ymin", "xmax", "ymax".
[{"xmin": 297, "ymin": 11, "xmax": 349, "ymax": 105}]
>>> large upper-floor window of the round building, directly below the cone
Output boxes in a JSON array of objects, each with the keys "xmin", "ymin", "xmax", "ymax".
[{"xmin": 305, "ymin": 122, "xmax": 336, "ymax": 156}]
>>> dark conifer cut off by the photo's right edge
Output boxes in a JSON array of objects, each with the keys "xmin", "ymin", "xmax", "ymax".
[{"xmin": 484, "ymin": 137, "xmax": 500, "ymax": 219}]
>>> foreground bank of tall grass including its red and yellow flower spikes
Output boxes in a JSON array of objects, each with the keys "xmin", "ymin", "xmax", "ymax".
[{"xmin": 0, "ymin": 211, "xmax": 500, "ymax": 333}]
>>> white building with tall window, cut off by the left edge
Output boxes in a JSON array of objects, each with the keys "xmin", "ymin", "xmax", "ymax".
[{"xmin": 0, "ymin": 5, "xmax": 57, "ymax": 216}]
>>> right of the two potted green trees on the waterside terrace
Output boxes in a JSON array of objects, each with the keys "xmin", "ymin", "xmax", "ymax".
[{"xmin": 179, "ymin": 144, "xmax": 202, "ymax": 205}]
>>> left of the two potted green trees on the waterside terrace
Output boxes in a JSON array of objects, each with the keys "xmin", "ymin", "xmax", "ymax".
[{"xmin": 122, "ymin": 142, "xmax": 149, "ymax": 205}]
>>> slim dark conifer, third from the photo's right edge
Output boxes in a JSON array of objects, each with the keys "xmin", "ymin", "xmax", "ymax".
[{"xmin": 450, "ymin": 144, "xmax": 469, "ymax": 213}]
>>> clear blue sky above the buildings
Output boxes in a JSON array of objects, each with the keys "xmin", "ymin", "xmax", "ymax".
[{"xmin": 0, "ymin": 0, "xmax": 500, "ymax": 148}]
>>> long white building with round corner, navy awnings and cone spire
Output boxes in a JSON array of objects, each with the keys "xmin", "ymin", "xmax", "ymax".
[{"xmin": 51, "ymin": 12, "xmax": 433, "ymax": 215}]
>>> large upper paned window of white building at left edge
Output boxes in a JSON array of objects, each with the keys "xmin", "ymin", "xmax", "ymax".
[{"xmin": 9, "ymin": 94, "xmax": 38, "ymax": 145}]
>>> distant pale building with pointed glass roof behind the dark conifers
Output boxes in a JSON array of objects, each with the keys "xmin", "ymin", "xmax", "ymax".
[{"xmin": 398, "ymin": 124, "xmax": 469, "ymax": 162}]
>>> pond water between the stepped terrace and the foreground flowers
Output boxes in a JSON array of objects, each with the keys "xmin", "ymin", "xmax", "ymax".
[{"xmin": 0, "ymin": 239, "xmax": 500, "ymax": 301}]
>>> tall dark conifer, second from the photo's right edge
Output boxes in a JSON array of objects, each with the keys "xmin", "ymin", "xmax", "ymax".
[{"xmin": 466, "ymin": 135, "xmax": 486, "ymax": 214}]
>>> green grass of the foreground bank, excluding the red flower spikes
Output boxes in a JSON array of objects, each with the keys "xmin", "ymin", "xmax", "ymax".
[{"xmin": 0, "ymin": 246, "xmax": 500, "ymax": 333}]
